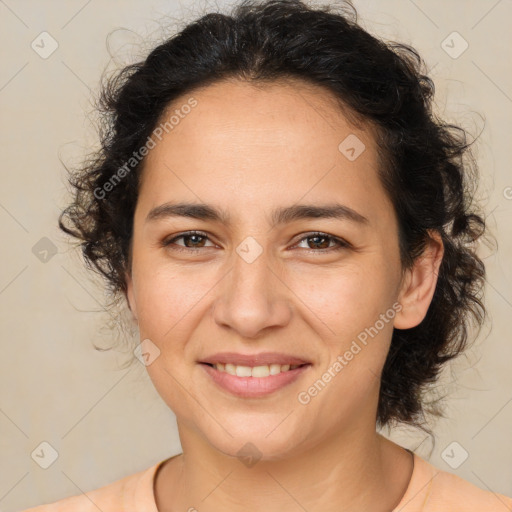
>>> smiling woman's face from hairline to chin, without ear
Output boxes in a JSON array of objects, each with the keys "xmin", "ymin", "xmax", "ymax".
[{"xmin": 128, "ymin": 82, "xmax": 424, "ymax": 459}]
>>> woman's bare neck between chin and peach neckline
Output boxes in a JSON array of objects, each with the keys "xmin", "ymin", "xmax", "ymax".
[{"xmin": 155, "ymin": 426, "xmax": 412, "ymax": 512}]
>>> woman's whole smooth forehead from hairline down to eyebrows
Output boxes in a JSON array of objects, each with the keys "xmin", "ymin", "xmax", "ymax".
[{"xmin": 135, "ymin": 77, "xmax": 389, "ymax": 224}]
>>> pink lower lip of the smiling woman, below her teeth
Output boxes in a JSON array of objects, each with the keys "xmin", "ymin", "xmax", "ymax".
[{"xmin": 200, "ymin": 363, "xmax": 311, "ymax": 398}]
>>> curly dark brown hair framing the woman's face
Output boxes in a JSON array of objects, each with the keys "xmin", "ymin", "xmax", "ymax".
[{"xmin": 59, "ymin": 0, "xmax": 486, "ymax": 428}]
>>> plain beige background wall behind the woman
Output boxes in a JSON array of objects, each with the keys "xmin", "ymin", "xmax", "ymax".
[{"xmin": 0, "ymin": 0, "xmax": 512, "ymax": 512}]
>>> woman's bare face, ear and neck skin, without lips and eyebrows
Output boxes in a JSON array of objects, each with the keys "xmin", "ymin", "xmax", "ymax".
[{"xmin": 126, "ymin": 81, "xmax": 443, "ymax": 512}]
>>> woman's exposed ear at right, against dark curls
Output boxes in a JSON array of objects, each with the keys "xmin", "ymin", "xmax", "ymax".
[{"xmin": 394, "ymin": 231, "xmax": 444, "ymax": 329}]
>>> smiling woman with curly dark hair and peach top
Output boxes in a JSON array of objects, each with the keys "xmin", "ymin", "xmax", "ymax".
[{"xmin": 24, "ymin": 0, "xmax": 512, "ymax": 512}]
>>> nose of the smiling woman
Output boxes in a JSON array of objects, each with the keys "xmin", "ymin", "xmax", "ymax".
[{"xmin": 213, "ymin": 245, "xmax": 292, "ymax": 339}]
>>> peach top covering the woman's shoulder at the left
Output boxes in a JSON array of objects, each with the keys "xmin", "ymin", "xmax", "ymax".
[{"xmin": 19, "ymin": 461, "xmax": 164, "ymax": 512}]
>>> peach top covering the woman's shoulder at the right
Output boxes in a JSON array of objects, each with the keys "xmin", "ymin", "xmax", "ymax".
[{"xmin": 404, "ymin": 455, "xmax": 512, "ymax": 512}]
